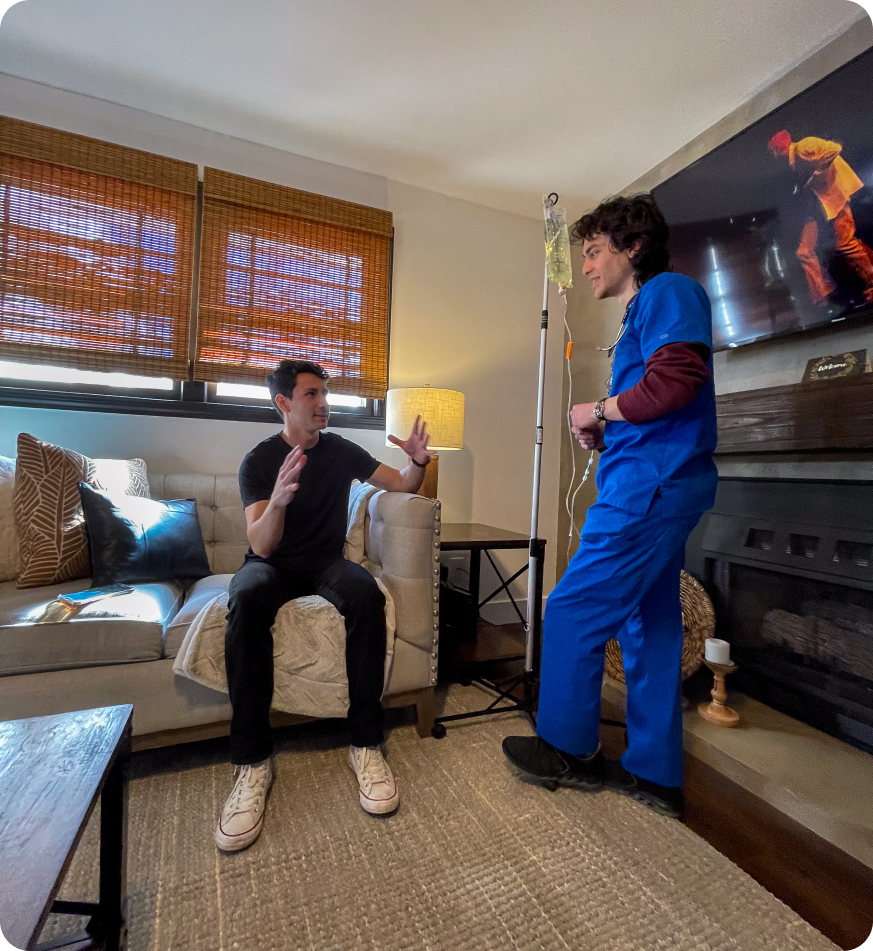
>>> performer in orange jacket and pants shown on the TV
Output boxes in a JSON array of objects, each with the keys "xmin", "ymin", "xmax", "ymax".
[{"xmin": 769, "ymin": 129, "xmax": 873, "ymax": 306}]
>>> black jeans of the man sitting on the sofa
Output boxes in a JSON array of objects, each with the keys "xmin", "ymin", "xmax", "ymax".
[{"xmin": 224, "ymin": 555, "xmax": 386, "ymax": 766}]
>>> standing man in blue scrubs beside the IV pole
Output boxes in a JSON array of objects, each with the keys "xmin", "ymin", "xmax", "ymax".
[{"xmin": 503, "ymin": 195, "xmax": 718, "ymax": 817}]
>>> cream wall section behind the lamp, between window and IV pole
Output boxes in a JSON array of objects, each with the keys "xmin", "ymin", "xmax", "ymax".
[{"xmin": 388, "ymin": 183, "xmax": 562, "ymax": 623}]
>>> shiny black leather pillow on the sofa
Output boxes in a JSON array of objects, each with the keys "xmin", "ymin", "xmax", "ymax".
[{"xmin": 79, "ymin": 482, "xmax": 211, "ymax": 587}]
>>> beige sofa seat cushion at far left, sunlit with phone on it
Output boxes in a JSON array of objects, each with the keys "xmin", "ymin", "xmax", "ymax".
[{"xmin": 0, "ymin": 580, "xmax": 182, "ymax": 676}]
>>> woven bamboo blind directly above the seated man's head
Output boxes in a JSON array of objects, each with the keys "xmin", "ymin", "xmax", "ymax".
[{"xmin": 194, "ymin": 168, "xmax": 393, "ymax": 399}]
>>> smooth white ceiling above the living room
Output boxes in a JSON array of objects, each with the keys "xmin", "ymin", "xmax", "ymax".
[{"xmin": 0, "ymin": 0, "xmax": 866, "ymax": 216}]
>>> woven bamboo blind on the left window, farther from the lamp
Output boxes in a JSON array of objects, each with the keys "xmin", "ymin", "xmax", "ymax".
[{"xmin": 0, "ymin": 117, "xmax": 197, "ymax": 379}]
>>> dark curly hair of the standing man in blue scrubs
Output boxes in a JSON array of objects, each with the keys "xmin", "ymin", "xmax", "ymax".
[{"xmin": 570, "ymin": 193, "xmax": 670, "ymax": 287}]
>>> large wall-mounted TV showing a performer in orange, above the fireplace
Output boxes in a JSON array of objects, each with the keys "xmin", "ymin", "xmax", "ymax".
[{"xmin": 653, "ymin": 50, "xmax": 873, "ymax": 350}]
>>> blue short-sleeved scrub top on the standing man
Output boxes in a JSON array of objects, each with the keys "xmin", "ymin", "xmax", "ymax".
[{"xmin": 597, "ymin": 272, "xmax": 718, "ymax": 518}]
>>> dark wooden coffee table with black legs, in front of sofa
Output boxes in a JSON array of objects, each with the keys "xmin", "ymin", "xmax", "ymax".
[{"xmin": 0, "ymin": 704, "xmax": 133, "ymax": 951}]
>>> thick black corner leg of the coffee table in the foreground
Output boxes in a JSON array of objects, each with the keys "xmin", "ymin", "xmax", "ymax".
[{"xmin": 100, "ymin": 724, "xmax": 131, "ymax": 951}]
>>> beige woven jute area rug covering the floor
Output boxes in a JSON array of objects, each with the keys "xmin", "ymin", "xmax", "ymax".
[{"xmin": 44, "ymin": 687, "xmax": 836, "ymax": 951}]
